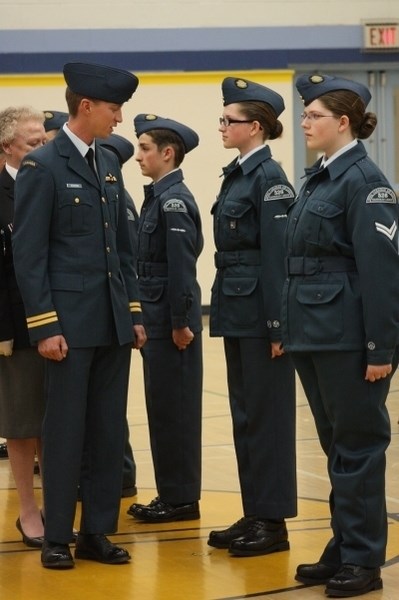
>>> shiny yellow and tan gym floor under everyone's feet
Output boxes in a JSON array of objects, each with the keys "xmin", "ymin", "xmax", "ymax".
[{"xmin": 0, "ymin": 327, "xmax": 399, "ymax": 600}]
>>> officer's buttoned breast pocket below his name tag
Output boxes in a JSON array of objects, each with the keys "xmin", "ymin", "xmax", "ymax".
[{"xmin": 58, "ymin": 189, "xmax": 95, "ymax": 235}]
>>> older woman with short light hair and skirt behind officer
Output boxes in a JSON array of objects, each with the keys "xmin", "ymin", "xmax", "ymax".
[{"xmin": 0, "ymin": 106, "xmax": 46, "ymax": 548}]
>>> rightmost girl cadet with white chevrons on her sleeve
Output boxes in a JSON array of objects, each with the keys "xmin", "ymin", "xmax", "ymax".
[{"xmin": 283, "ymin": 75, "xmax": 399, "ymax": 597}]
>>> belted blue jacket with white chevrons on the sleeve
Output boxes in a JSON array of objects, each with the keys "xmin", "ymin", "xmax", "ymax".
[{"xmin": 283, "ymin": 142, "xmax": 399, "ymax": 364}]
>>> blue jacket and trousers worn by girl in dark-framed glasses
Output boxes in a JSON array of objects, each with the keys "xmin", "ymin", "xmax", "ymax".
[{"xmin": 210, "ymin": 146, "xmax": 297, "ymax": 519}]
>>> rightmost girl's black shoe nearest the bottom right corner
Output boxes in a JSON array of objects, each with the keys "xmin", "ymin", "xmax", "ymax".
[{"xmin": 325, "ymin": 565, "xmax": 382, "ymax": 598}]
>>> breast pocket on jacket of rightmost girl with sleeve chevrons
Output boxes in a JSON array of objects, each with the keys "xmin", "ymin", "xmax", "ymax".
[{"xmin": 304, "ymin": 200, "xmax": 344, "ymax": 247}]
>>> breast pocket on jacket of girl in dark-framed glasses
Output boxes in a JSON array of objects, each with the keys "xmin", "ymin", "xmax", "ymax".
[{"xmin": 220, "ymin": 202, "xmax": 255, "ymax": 242}]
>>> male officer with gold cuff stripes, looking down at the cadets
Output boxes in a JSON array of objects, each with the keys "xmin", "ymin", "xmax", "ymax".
[{"xmin": 14, "ymin": 63, "xmax": 146, "ymax": 569}]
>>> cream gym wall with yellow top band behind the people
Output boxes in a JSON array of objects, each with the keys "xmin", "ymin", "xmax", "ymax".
[{"xmin": 0, "ymin": 70, "xmax": 294, "ymax": 306}]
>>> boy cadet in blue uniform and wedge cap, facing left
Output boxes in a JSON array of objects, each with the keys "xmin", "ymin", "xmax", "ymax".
[{"xmin": 128, "ymin": 114, "xmax": 203, "ymax": 523}]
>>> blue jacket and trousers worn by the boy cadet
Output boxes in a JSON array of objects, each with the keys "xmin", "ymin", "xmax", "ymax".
[{"xmin": 138, "ymin": 169, "xmax": 203, "ymax": 504}]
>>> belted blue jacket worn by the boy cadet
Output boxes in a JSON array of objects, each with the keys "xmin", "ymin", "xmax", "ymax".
[{"xmin": 138, "ymin": 169, "xmax": 203, "ymax": 339}]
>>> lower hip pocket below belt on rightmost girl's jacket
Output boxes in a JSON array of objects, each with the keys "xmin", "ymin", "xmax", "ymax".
[{"xmin": 296, "ymin": 282, "xmax": 344, "ymax": 344}]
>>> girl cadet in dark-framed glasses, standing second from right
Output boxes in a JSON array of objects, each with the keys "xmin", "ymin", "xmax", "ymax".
[{"xmin": 208, "ymin": 77, "xmax": 297, "ymax": 556}]
